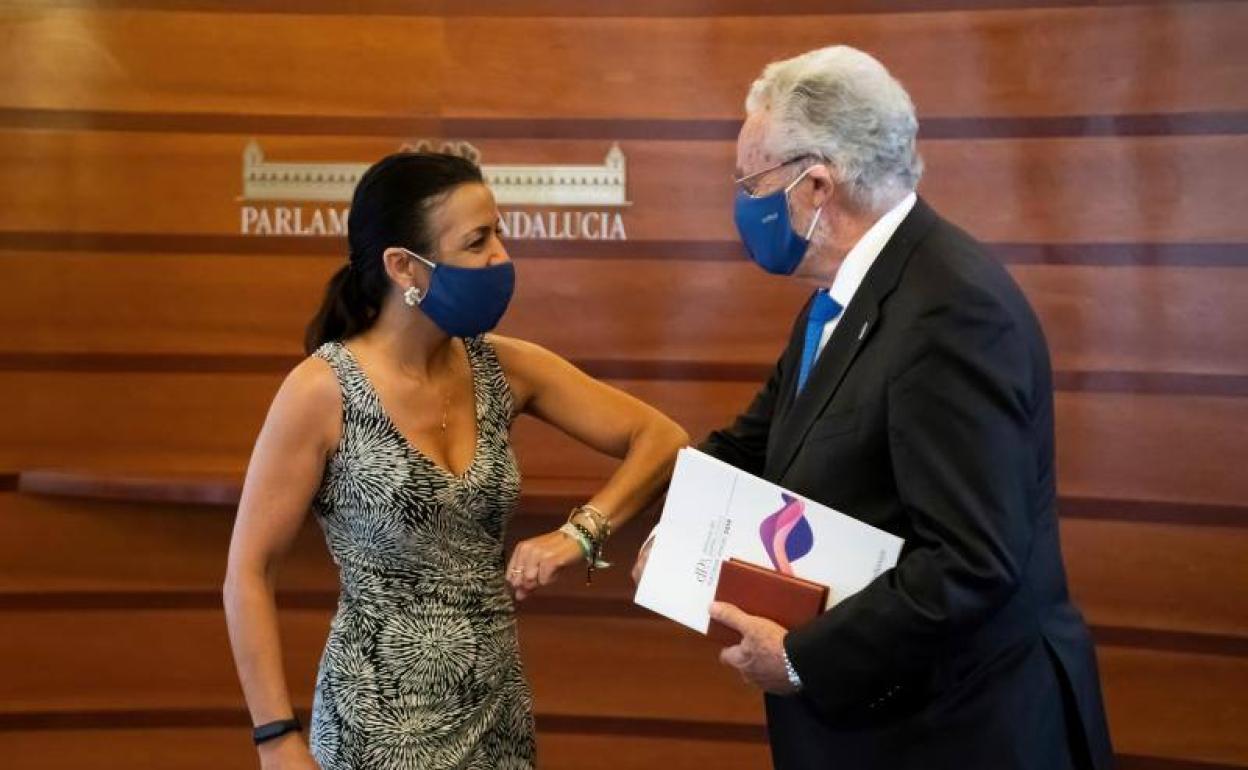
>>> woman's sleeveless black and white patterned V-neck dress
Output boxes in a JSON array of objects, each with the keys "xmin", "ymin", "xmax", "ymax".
[{"xmin": 310, "ymin": 338, "xmax": 534, "ymax": 770}]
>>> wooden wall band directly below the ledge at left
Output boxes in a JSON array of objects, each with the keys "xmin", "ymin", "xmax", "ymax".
[{"xmin": 0, "ymin": 493, "xmax": 1248, "ymax": 636}]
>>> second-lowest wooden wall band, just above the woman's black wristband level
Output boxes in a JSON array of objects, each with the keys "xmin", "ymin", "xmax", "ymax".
[{"xmin": 0, "ymin": 610, "xmax": 1248, "ymax": 763}]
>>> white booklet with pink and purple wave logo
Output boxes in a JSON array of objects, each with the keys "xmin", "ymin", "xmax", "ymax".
[{"xmin": 634, "ymin": 448, "xmax": 902, "ymax": 634}]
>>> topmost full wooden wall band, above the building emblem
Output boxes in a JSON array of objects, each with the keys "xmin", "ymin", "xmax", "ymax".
[{"xmin": 9, "ymin": 4, "xmax": 1248, "ymax": 117}]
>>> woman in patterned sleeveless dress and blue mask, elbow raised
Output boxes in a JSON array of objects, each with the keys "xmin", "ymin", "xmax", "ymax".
[{"xmin": 225, "ymin": 154, "xmax": 688, "ymax": 770}]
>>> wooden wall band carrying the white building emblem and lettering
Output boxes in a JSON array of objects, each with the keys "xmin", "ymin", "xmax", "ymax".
[{"xmin": 0, "ymin": 130, "xmax": 1248, "ymax": 242}]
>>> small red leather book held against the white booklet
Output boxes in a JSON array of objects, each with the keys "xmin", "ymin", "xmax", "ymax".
[{"xmin": 706, "ymin": 559, "xmax": 827, "ymax": 646}]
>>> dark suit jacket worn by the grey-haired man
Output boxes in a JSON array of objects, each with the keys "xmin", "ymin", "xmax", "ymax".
[{"xmin": 703, "ymin": 200, "xmax": 1112, "ymax": 770}]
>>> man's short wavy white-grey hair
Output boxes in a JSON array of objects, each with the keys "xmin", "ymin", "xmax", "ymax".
[{"xmin": 745, "ymin": 45, "xmax": 924, "ymax": 212}]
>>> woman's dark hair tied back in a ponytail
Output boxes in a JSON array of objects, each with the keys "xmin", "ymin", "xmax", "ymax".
[{"xmin": 303, "ymin": 152, "xmax": 484, "ymax": 353}]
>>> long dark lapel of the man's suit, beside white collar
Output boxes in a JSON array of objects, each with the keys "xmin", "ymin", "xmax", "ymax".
[{"xmin": 766, "ymin": 198, "xmax": 936, "ymax": 479}]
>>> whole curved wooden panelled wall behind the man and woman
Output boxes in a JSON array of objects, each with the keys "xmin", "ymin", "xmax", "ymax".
[{"xmin": 0, "ymin": 0, "xmax": 1248, "ymax": 770}]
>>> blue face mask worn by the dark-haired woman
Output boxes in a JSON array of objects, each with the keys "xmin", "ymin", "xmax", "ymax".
[{"xmin": 403, "ymin": 248, "xmax": 515, "ymax": 337}]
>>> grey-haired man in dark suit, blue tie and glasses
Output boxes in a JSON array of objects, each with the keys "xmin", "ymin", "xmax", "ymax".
[{"xmin": 639, "ymin": 46, "xmax": 1112, "ymax": 770}]
